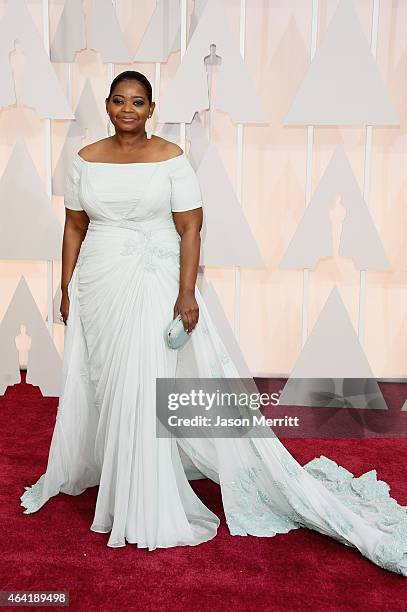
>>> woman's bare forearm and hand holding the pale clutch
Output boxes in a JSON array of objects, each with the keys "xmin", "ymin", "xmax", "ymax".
[{"xmin": 173, "ymin": 208, "xmax": 203, "ymax": 333}]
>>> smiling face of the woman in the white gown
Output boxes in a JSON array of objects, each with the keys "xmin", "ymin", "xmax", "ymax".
[{"xmin": 106, "ymin": 80, "xmax": 155, "ymax": 133}]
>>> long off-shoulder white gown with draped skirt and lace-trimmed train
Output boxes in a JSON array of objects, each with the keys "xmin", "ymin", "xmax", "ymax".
[{"xmin": 20, "ymin": 153, "xmax": 407, "ymax": 576}]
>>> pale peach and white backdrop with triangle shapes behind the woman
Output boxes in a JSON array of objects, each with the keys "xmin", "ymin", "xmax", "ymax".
[{"xmin": 0, "ymin": 0, "xmax": 407, "ymax": 388}]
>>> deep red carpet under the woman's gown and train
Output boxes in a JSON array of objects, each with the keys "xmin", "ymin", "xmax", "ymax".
[{"xmin": 0, "ymin": 372, "xmax": 407, "ymax": 612}]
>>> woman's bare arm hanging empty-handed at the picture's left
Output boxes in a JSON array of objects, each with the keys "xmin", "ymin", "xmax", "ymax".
[{"xmin": 60, "ymin": 208, "xmax": 89, "ymax": 325}]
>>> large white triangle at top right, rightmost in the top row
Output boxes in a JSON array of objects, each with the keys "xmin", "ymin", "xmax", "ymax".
[{"xmin": 284, "ymin": 0, "xmax": 399, "ymax": 125}]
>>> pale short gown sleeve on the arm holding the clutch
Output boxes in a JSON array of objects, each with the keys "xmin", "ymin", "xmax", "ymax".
[{"xmin": 170, "ymin": 153, "xmax": 202, "ymax": 212}]
